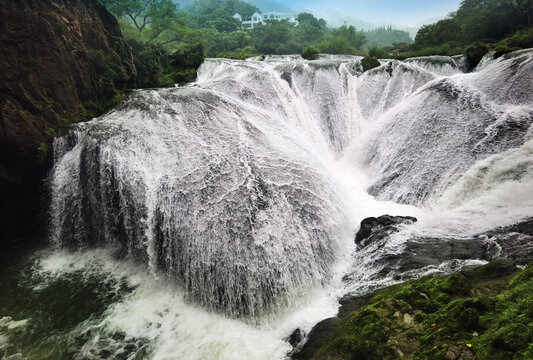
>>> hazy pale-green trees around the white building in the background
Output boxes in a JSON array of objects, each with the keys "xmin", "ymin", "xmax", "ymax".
[{"xmin": 97, "ymin": 0, "xmax": 412, "ymax": 58}]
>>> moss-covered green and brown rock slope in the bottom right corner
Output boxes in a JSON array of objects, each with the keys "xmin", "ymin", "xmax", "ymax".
[{"xmin": 304, "ymin": 263, "xmax": 533, "ymax": 360}]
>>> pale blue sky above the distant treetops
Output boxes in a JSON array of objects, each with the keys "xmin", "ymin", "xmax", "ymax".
[{"xmin": 256, "ymin": 0, "xmax": 461, "ymax": 27}]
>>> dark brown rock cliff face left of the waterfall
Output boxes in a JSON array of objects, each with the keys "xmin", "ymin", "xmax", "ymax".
[{"xmin": 0, "ymin": 0, "xmax": 135, "ymax": 241}]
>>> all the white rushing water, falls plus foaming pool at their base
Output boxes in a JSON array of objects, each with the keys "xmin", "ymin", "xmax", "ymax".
[{"xmin": 5, "ymin": 50, "xmax": 533, "ymax": 359}]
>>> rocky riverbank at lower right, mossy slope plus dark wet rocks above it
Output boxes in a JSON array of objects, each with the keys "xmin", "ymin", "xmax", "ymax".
[{"xmin": 292, "ymin": 216, "xmax": 533, "ymax": 360}]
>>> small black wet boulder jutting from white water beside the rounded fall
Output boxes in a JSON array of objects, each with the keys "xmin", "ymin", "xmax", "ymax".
[{"xmin": 355, "ymin": 215, "xmax": 417, "ymax": 247}]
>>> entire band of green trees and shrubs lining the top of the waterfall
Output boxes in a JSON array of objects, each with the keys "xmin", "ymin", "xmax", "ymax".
[{"xmin": 99, "ymin": 0, "xmax": 533, "ymax": 81}]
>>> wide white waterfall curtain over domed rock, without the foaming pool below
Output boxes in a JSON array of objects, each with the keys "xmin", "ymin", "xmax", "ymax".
[{"xmin": 50, "ymin": 50, "xmax": 533, "ymax": 324}]
